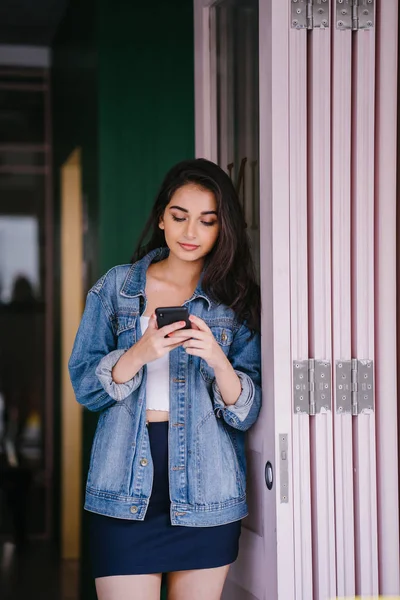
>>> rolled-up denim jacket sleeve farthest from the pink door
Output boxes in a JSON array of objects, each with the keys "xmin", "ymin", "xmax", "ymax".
[{"xmin": 68, "ymin": 291, "xmax": 143, "ymax": 411}]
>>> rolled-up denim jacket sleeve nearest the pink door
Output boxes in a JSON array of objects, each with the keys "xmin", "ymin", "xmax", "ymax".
[{"xmin": 213, "ymin": 325, "xmax": 261, "ymax": 431}]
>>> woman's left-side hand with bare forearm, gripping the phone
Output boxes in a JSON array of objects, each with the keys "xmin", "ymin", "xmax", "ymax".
[{"xmin": 112, "ymin": 313, "xmax": 190, "ymax": 383}]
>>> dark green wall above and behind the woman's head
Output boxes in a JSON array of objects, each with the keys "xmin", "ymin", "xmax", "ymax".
[{"xmin": 99, "ymin": 0, "xmax": 194, "ymax": 269}]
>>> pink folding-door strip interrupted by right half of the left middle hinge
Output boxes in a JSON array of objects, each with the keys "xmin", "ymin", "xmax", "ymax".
[{"xmin": 308, "ymin": 23, "xmax": 336, "ymax": 600}]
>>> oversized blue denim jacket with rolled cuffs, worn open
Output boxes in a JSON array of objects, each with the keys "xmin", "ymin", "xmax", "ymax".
[{"xmin": 69, "ymin": 248, "xmax": 261, "ymax": 527}]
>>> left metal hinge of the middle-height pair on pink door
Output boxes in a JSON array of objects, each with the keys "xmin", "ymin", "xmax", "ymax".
[{"xmin": 293, "ymin": 358, "xmax": 332, "ymax": 415}]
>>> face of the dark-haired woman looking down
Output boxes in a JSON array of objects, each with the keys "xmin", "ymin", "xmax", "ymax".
[{"xmin": 159, "ymin": 184, "xmax": 220, "ymax": 262}]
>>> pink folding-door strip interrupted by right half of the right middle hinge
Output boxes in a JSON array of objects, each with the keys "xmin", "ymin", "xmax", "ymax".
[{"xmin": 352, "ymin": 22, "xmax": 379, "ymax": 595}]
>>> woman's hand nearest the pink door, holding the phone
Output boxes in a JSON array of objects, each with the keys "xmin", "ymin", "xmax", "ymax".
[{"xmin": 170, "ymin": 315, "xmax": 230, "ymax": 371}]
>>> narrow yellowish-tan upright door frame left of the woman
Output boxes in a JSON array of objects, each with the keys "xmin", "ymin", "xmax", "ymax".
[{"xmin": 61, "ymin": 148, "xmax": 84, "ymax": 559}]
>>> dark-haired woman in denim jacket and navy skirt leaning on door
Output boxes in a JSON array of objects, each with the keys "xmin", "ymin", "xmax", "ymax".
[{"xmin": 69, "ymin": 159, "xmax": 261, "ymax": 600}]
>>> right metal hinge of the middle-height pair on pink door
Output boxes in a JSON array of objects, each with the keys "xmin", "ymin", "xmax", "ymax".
[{"xmin": 336, "ymin": 359, "xmax": 374, "ymax": 416}]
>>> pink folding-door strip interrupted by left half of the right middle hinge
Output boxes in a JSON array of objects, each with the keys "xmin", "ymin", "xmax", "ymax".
[{"xmin": 331, "ymin": 3, "xmax": 355, "ymax": 597}]
